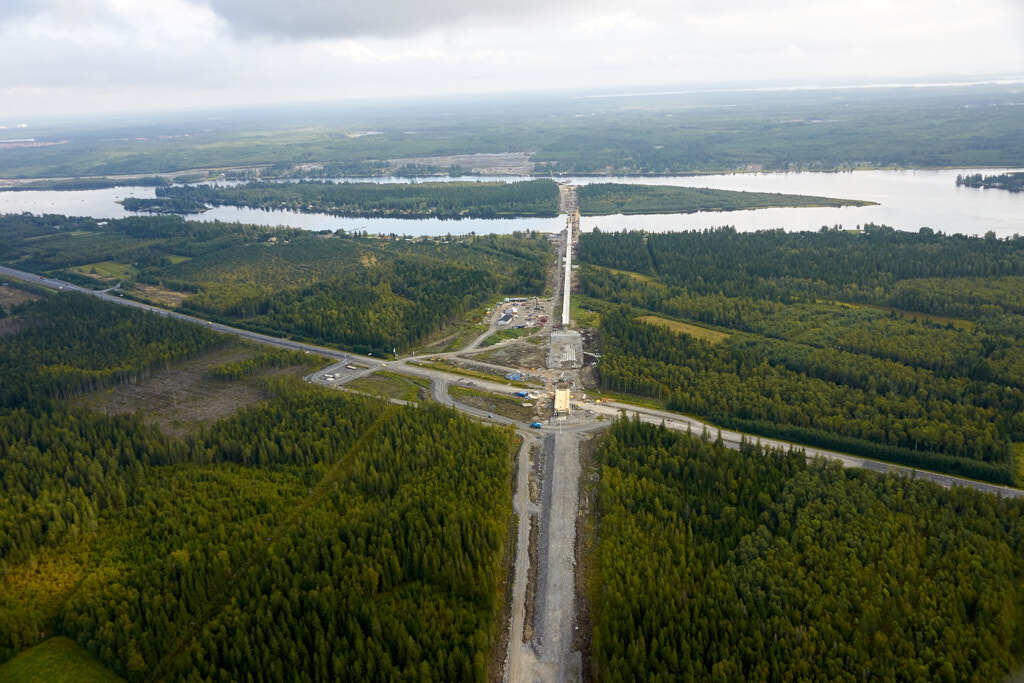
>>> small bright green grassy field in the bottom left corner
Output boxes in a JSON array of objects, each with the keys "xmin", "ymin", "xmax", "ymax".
[{"xmin": 0, "ymin": 637, "xmax": 123, "ymax": 683}]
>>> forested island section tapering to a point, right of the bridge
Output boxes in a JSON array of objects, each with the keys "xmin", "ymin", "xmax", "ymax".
[{"xmin": 577, "ymin": 182, "xmax": 871, "ymax": 216}]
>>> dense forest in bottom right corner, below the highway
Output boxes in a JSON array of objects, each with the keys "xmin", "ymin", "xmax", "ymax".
[{"xmin": 591, "ymin": 421, "xmax": 1024, "ymax": 682}]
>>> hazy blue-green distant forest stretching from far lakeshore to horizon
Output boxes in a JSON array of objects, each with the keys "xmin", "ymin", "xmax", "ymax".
[{"xmin": 0, "ymin": 85, "xmax": 1024, "ymax": 178}]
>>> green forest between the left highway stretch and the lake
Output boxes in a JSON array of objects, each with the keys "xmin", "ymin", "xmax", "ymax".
[{"xmin": 0, "ymin": 215, "xmax": 552, "ymax": 354}]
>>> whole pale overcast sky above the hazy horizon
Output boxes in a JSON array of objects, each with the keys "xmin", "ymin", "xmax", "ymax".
[{"xmin": 0, "ymin": 0, "xmax": 1024, "ymax": 118}]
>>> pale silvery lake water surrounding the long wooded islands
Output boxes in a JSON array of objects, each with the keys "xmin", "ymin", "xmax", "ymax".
[{"xmin": 0, "ymin": 168, "xmax": 1024, "ymax": 237}]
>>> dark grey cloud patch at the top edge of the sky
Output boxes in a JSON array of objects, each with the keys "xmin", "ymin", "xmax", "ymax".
[{"xmin": 195, "ymin": 0, "xmax": 547, "ymax": 39}]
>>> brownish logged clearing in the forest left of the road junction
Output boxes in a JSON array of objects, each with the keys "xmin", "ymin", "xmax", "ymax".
[{"xmin": 74, "ymin": 344, "xmax": 306, "ymax": 437}]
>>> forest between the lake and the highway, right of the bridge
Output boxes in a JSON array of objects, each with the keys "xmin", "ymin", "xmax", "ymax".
[{"xmin": 580, "ymin": 227, "xmax": 1024, "ymax": 482}]
